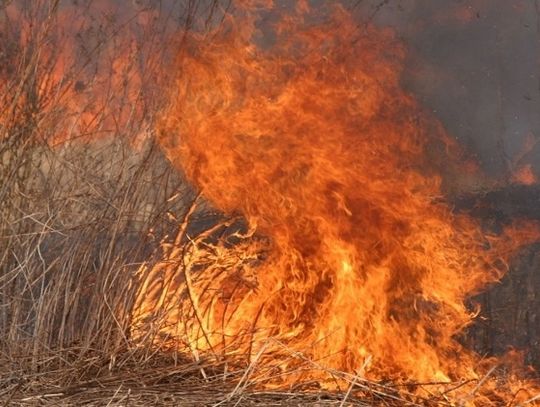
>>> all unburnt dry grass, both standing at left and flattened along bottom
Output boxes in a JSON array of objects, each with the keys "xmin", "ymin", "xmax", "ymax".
[{"xmin": 0, "ymin": 1, "xmax": 540, "ymax": 406}]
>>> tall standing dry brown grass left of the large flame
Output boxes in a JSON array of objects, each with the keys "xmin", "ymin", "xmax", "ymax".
[{"xmin": 0, "ymin": 1, "xmax": 200, "ymax": 404}]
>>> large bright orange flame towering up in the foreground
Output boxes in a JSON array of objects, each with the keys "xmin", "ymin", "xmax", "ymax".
[{"xmin": 134, "ymin": 1, "xmax": 538, "ymax": 405}]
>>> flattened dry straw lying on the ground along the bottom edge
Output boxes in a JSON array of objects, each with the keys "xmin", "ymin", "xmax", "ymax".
[{"xmin": 7, "ymin": 348, "xmax": 534, "ymax": 406}]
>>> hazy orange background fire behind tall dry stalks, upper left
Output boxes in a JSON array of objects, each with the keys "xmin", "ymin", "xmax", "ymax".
[{"xmin": 0, "ymin": 0, "xmax": 170, "ymax": 145}]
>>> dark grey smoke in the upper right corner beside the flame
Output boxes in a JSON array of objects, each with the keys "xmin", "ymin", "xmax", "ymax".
[{"xmin": 357, "ymin": 0, "xmax": 540, "ymax": 179}]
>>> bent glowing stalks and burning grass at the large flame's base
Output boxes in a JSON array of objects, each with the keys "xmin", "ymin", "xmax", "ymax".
[{"xmin": 132, "ymin": 200, "xmax": 537, "ymax": 406}]
